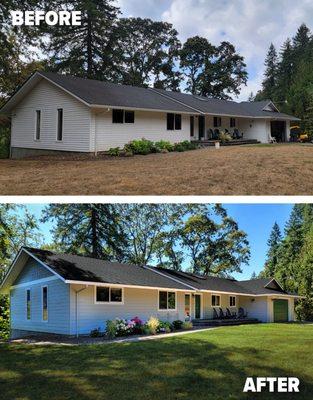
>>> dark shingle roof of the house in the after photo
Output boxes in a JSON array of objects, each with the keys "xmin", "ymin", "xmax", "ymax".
[{"xmin": 24, "ymin": 247, "xmax": 288, "ymax": 295}]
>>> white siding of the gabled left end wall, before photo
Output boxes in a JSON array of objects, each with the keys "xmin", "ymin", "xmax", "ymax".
[{"xmin": 11, "ymin": 80, "xmax": 91, "ymax": 152}]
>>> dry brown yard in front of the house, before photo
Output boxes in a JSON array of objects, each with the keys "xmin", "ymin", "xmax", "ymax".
[{"xmin": 0, "ymin": 144, "xmax": 313, "ymax": 195}]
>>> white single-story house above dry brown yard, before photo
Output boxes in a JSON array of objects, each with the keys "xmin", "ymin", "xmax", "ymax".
[{"xmin": 0, "ymin": 72, "xmax": 298, "ymax": 158}]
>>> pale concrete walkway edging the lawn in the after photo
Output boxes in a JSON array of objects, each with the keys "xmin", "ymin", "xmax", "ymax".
[{"xmin": 10, "ymin": 327, "xmax": 218, "ymax": 346}]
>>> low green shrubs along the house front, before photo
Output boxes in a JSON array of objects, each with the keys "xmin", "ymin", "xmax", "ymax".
[{"xmin": 108, "ymin": 138, "xmax": 199, "ymax": 157}]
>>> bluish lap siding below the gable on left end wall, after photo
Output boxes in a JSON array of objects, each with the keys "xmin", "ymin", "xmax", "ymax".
[{"xmin": 11, "ymin": 280, "xmax": 70, "ymax": 334}]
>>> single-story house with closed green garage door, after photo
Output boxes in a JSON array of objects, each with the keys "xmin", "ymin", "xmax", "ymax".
[{"xmin": 0, "ymin": 247, "xmax": 299, "ymax": 337}]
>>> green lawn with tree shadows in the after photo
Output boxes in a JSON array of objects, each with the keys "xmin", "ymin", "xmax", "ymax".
[{"xmin": 0, "ymin": 324, "xmax": 313, "ymax": 400}]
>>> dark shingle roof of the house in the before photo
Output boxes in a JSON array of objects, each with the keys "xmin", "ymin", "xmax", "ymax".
[{"xmin": 39, "ymin": 72, "xmax": 298, "ymax": 120}]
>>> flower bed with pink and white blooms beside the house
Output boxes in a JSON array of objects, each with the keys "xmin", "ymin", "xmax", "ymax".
[{"xmin": 90, "ymin": 317, "xmax": 193, "ymax": 339}]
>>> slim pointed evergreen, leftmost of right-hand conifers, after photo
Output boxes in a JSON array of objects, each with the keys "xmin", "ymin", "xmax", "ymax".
[{"xmin": 261, "ymin": 222, "xmax": 282, "ymax": 278}]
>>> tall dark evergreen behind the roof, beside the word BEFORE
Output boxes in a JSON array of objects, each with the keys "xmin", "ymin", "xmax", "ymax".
[{"xmin": 43, "ymin": 0, "xmax": 119, "ymax": 80}]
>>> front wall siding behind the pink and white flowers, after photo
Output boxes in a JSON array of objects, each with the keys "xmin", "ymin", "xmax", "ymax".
[{"xmin": 71, "ymin": 285, "xmax": 184, "ymax": 334}]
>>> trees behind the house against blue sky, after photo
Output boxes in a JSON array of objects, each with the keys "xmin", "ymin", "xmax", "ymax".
[{"xmin": 0, "ymin": 204, "xmax": 313, "ymax": 336}]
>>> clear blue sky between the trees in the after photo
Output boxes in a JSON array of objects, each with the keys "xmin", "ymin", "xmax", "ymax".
[{"xmin": 18, "ymin": 204, "xmax": 293, "ymax": 279}]
